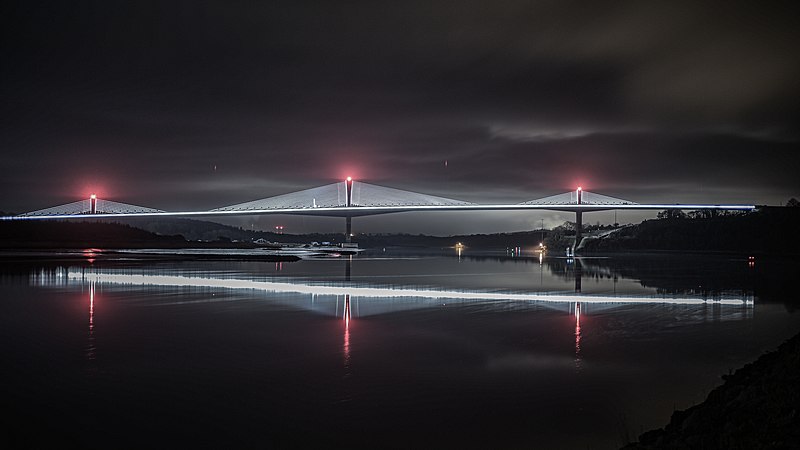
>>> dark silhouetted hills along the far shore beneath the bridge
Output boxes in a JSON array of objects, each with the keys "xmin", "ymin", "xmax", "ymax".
[{"xmin": 6, "ymin": 208, "xmax": 800, "ymax": 255}]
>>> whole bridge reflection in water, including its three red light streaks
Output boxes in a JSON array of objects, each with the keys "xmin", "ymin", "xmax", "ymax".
[{"xmin": 30, "ymin": 258, "xmax": 754, "ymax": 374}]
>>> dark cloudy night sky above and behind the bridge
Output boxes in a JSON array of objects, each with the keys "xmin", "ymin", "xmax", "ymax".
[{"xmin": 0, "ymin": 0, "xmax": 800, "ymax": 234}]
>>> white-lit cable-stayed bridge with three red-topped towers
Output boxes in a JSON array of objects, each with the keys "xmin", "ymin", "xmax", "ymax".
[{"xmin": 2, "ymin": 177, "xmax": 756, "ymax": 241}]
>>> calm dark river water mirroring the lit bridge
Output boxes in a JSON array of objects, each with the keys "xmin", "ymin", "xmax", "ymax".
[{"xmin": 0, "ymin": 250, "xmax": 800, "ymax": 449}]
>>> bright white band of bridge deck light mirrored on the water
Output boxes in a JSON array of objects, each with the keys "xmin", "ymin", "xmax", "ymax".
[{"xmin": 31, "ymin": 266, "xmax": 754, "ymax": 321}]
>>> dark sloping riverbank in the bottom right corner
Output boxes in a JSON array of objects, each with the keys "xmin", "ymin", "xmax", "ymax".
[{"xmin": 624, "ymin": 328, "xmax": 800, "ymax": 450}]
